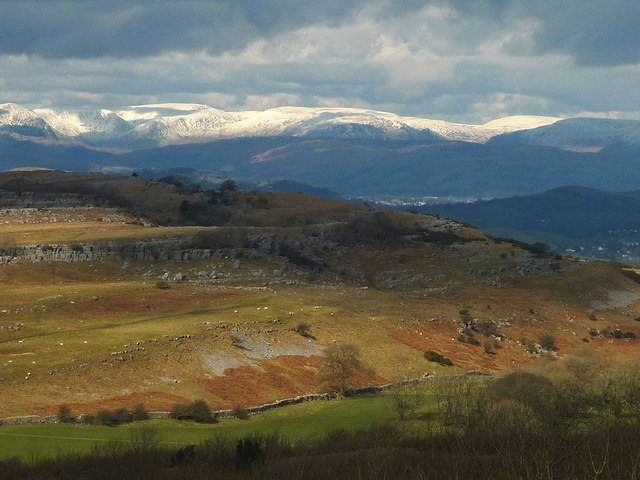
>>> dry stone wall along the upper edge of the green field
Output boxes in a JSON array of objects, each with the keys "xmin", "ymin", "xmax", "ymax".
[{"xmin": 0, "ymin": 370, "xmax": 492, "ymax": 426}]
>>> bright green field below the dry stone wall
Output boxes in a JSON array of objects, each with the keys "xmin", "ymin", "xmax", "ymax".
[{"xmin": 0, "ymin": 395, "xmax": 394, "ymax": 461}]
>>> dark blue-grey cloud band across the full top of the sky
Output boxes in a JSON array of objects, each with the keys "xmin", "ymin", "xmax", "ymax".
[{"xmin": 0, "ymin": 0, "xmax": 640, "ymax": 65}]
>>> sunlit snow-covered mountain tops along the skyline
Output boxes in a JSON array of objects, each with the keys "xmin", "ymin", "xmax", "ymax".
[{"xmin": 0, "ymin": 103, "xmax": 562, "ymax": 150}]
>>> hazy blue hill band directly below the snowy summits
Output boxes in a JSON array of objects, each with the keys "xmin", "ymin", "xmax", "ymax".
[{"xmin": 0, "ymin": 134, "xmax": 640, "ymax": 198}]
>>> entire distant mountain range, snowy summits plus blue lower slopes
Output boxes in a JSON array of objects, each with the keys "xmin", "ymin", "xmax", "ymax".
[{"xmin": 0, "ymin": 104, "xmax": 640, "ymax": 199}]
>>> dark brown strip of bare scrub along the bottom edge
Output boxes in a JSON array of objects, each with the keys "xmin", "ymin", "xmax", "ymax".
[{"xmin": 17, "ymin": 404, "xmax": 640, "ymax": 480}]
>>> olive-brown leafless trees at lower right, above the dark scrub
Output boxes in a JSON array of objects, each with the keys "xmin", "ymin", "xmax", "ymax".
[{"xmin": 434, "ymin": 350, "xmax": 640, "ymax": 431}]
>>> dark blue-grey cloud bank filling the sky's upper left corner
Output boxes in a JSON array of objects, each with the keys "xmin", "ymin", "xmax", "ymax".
[{"xmin": 0, "ymin": 0, "xmax": 368, "ymax": 58}]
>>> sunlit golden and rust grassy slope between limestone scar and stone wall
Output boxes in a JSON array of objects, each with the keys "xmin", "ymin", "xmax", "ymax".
[{"xmin": 0, "ymin": 232, "xmax": 640, "ymax": 415}]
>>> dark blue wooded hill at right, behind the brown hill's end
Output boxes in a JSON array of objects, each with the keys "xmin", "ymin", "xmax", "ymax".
[{"xmin": 418, "ymin": 187, "xmax": 640, "ymax": 266}]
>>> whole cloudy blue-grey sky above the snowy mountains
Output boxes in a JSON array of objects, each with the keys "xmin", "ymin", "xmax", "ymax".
[{"xmin": 0, "ymin": 0, "xmax": 640, "ymax": 123}]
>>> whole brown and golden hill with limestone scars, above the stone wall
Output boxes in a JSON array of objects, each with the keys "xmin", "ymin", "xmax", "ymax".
[{"xmin": 0, "ymin": 171, "xmax": 640, "ymax": 416}]
